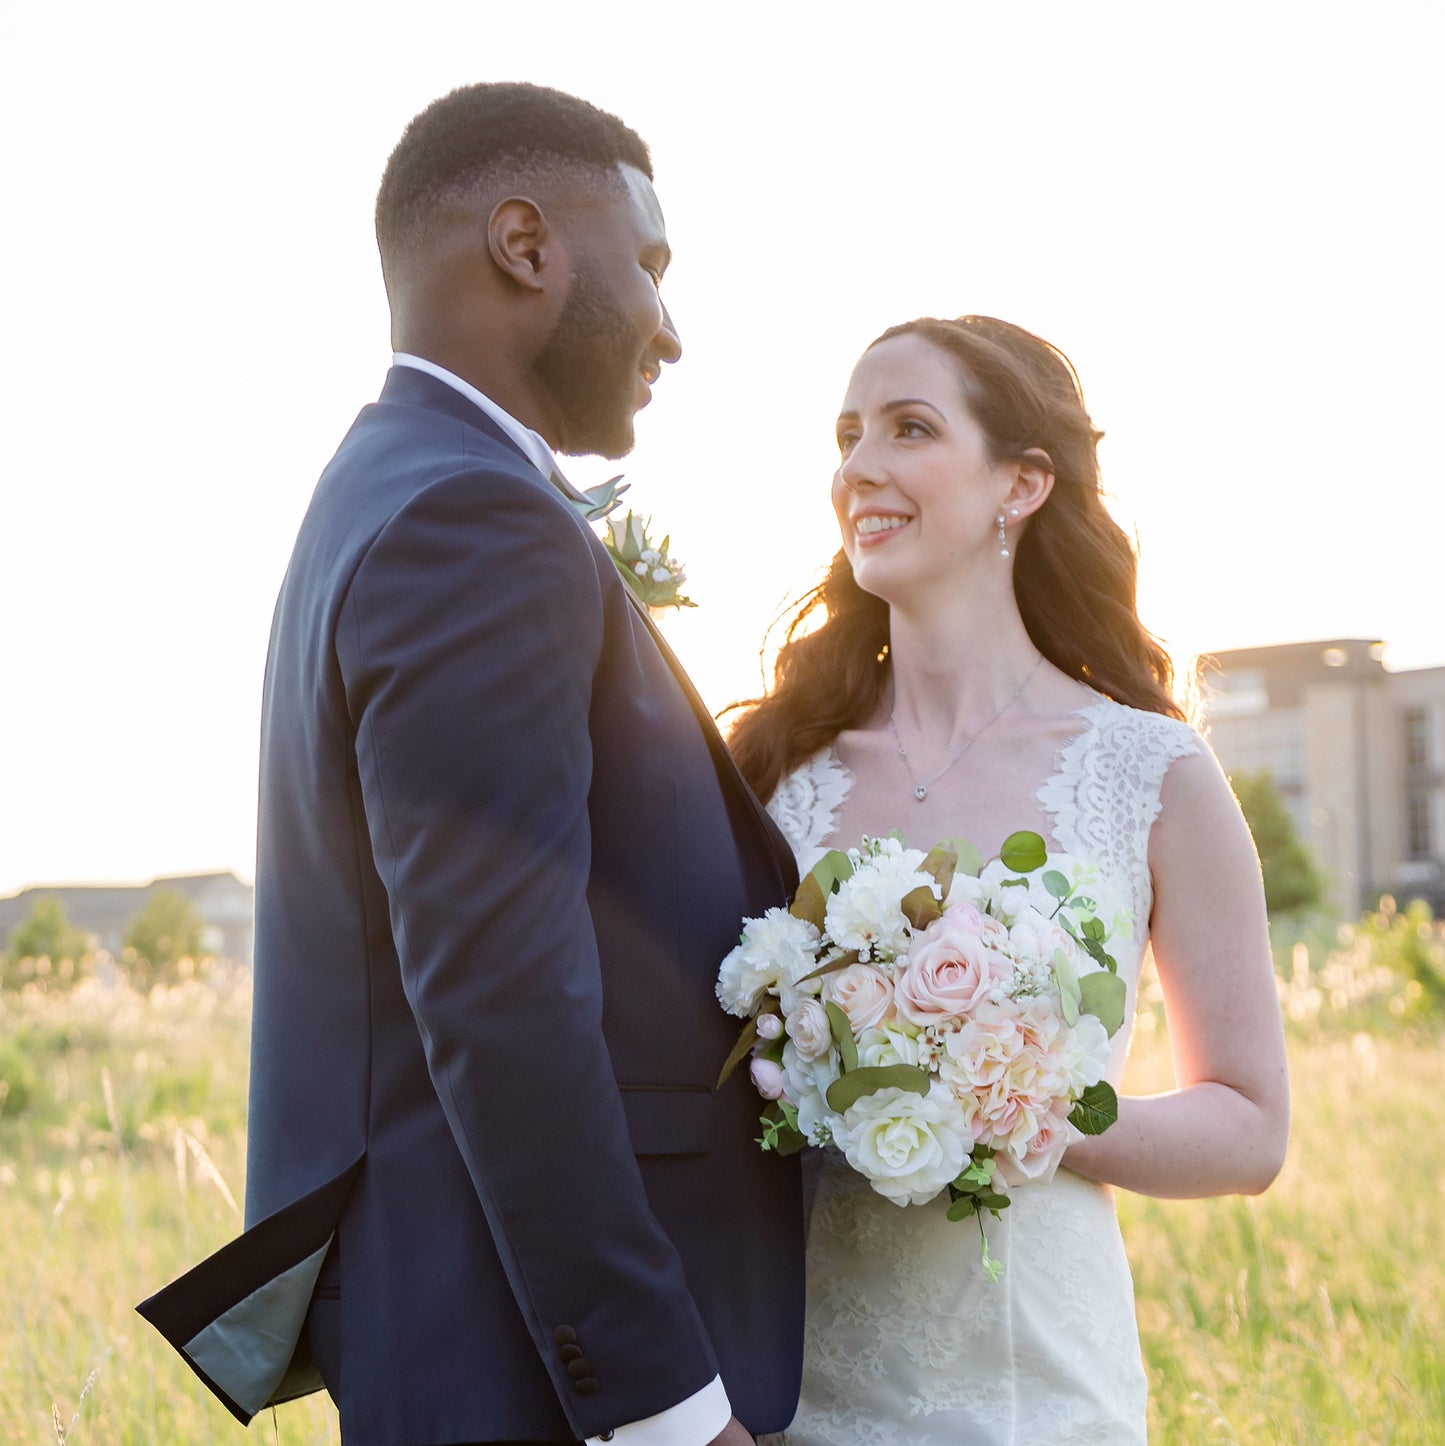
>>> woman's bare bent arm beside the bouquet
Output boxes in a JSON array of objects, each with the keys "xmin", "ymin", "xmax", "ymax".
[{"xmin": 1063, "ymin": 753, "xmax": 1289, "ymax": 1197}]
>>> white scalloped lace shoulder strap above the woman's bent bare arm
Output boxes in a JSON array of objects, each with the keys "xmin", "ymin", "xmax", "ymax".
[{"xmin": 1039, "ymin": 698, "xmax": 1205, "ymax": 933}]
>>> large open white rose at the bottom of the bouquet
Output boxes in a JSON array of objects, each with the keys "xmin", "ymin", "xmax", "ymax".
[{"xmin": 833, "ymin": 1085, "xmax": 973, "ymax": 1205}]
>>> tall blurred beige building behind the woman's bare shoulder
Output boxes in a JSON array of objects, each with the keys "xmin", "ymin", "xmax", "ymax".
[{"xmin": 1205, "ymin": 638, "xmax": 1445, "ymax": 914}]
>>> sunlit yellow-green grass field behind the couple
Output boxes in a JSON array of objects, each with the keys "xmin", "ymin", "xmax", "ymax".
[{"xmin": 0, "ymin": 942, "xmax": 1445, "ymax": 1446}]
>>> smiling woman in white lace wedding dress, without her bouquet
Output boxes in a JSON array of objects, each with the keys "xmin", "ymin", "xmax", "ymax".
[{"xmin": 732, "ymin": 317, "xmax": 1289, "ymax": 1446}]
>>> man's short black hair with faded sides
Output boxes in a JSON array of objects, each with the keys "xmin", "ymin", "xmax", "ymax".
[{"xmin": 376, "ymin": 81, "xmax": 652, "ymax": 260}]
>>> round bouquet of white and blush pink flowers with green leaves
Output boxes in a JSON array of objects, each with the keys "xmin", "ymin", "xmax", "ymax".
[{"xmin": 717, "ymin": 833, "xmax": 1127, "ymax": 1278}]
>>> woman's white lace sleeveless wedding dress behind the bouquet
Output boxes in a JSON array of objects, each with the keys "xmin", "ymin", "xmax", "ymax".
[{"xmin": 764, "ymin": 697, "xmax": 1203, "ymax": 1446}]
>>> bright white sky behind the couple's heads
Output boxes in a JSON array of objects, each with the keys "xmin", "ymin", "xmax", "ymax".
[{"xmin": 0, "ymin": 0, "xmax": 1445, "ymax": 895}]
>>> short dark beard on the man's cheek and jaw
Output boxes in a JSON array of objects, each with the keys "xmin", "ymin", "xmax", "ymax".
[{"xmin": 534, "ymin": 268, "xmax": 641, "ymax": 457}]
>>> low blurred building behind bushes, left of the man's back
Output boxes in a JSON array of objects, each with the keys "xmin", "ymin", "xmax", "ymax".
[{"xmin": 0, "ymin": 873, "xmax": 255, "ymax": 967}]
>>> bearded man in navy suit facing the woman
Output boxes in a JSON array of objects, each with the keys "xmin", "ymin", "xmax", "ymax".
[{"xmin": 140, "ymin": 84, "xmax": 801, "ymax": 1446}]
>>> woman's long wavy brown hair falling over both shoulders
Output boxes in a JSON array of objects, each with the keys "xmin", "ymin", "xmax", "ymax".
[{"xmin": 729, "ymin": 317, "xmax": 1185, "ymax": 800}]
